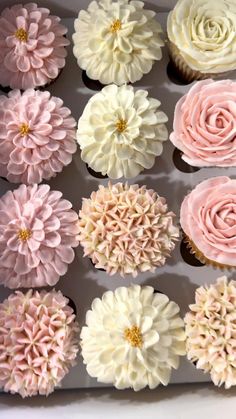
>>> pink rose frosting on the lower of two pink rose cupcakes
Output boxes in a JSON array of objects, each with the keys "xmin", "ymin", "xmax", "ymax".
[{"xmin": 180, "ymin": 176, "xmax": 236, "ymax": 266}]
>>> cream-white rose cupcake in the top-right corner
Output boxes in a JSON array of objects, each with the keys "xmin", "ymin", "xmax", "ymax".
[{"xmin": 167, "ymin": 0, "xmax": 236, "ymax": 82}]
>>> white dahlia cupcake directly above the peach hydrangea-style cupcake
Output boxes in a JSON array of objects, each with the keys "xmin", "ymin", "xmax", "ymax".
[{"xmin": 77, "ymin": 84, "xmax": 168, "ymax": 179}]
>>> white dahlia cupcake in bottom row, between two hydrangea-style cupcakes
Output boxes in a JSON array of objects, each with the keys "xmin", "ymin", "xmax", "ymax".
[{"xmin": 81, "ymin": 285, "xmax": 185, "ymax": 391}]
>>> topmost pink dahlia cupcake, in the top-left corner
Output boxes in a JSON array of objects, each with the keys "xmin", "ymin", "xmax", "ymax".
[{"xmin": 0, "ymin": 3, "xmax": 69, "ymax": 90}]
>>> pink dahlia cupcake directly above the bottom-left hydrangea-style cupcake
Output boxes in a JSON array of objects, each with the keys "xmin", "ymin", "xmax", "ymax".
[{"xmin": 0, "ymin": 185, "xmax": 78, "ymax": 288}]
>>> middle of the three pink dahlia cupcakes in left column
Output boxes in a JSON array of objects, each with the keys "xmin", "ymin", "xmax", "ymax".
[{"xmin": 0, "ymin": 89, "xmax": 76, "ymax": 184}]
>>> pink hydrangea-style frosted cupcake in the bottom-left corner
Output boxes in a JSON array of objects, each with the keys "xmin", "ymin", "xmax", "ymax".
[{"xmin": 0, "ymin": 290, "xmax": 79, "ymax": 397}]
